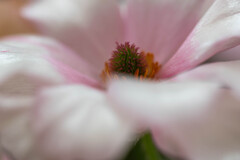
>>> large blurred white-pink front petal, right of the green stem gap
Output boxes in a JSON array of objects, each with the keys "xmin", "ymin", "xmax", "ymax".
[{"xmin": 109, "ymin": 61, "xmax": 240, "ymax": 160}]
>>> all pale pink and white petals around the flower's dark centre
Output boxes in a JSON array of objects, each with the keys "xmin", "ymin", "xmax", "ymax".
[{"xmin": 0, "ymin": 0, "xmax": 240, "ymax": 160}]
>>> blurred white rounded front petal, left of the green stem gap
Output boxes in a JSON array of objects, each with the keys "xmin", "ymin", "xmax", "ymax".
[{"xmin": 33, "ymin": 85, "xmax": 135, "ymax": 160}]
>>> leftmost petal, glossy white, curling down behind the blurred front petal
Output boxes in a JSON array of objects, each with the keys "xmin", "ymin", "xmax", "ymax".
[{"xmin": 0, "ymin": 37, "xmax": 98, "ymax": 156}]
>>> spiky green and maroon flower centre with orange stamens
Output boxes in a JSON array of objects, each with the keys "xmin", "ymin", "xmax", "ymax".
[{"xmin": 101, "ymin": 42, "xmax": 161, "ymax": 82}]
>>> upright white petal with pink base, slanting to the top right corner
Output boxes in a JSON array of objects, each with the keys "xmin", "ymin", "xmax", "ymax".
[{"xmin": 161, "ymin": 0, "xmax": 240, "ymax": 77}]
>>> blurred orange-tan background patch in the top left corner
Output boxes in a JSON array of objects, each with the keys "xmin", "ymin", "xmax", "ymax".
[{"xmin": 0, "ymin": 0, "xmax": 34, "ymax": 37}]
